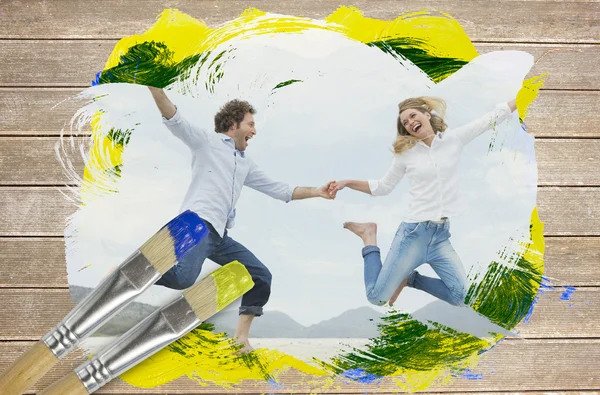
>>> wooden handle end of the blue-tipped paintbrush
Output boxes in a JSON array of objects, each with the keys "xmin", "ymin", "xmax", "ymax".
[{"xmin": 0, "ymin": 341, "xmax": 58, "ymax": 395}]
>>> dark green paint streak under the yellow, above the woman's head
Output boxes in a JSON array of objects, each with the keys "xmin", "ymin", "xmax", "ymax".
[{"xmin": 367, "ymin": 37, "xmax": 469, "ymax": 83}]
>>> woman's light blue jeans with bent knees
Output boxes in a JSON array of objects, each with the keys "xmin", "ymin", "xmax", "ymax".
[{"xmin": 362, "ymin": 220, "xmax": 467, "ymax": 306}]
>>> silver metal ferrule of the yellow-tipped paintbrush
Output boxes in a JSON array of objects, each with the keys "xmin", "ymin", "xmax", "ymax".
[{"xmin": 75, "ymin": 296, "xmax": 202, "ymax": 393}]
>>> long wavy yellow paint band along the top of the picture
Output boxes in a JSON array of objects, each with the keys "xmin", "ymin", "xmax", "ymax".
[{"xmin": 105, "ymin": 7, "xmax": 477, "ymax": 69}]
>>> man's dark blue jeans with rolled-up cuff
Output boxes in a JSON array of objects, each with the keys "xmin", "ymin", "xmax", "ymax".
[{"xmin": 156, "ymin": 221, "xmax": 271, "ymax": 316}]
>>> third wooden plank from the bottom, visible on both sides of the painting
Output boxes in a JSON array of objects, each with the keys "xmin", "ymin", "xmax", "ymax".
[{"xmin": 0, "ymin": 237, "xmax": 600, "ymax": 288}]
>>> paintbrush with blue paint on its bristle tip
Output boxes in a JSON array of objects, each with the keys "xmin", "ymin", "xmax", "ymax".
[{"xmin": 0, "ymin": 210, "xmax": 208, "ymax": 395}]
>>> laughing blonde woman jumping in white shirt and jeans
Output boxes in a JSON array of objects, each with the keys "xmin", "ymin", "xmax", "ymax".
[{"xmin": 329, "ymin": 97, "xmax": 516, "ymax": 306}]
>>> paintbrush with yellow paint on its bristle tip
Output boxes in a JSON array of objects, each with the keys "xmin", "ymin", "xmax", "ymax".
[{"xmin": 38, "ymin": 261, "xmax": 254, "ymax": 395}]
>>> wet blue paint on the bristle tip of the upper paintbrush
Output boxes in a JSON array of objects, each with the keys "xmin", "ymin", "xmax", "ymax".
[{"xmin": 166, "ymin": 210, "xmax": 208, "ymax": 261}]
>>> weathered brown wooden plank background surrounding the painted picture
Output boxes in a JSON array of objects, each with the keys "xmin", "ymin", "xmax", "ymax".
[{"xmin": 0, "ymin": 0, "xmax": 600, "ymax": 394}]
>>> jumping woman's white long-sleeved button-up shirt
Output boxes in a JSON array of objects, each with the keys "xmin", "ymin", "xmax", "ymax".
[{"xmin": 368, "ymin": 103, "xmax": 512, "ymax": 222}]
